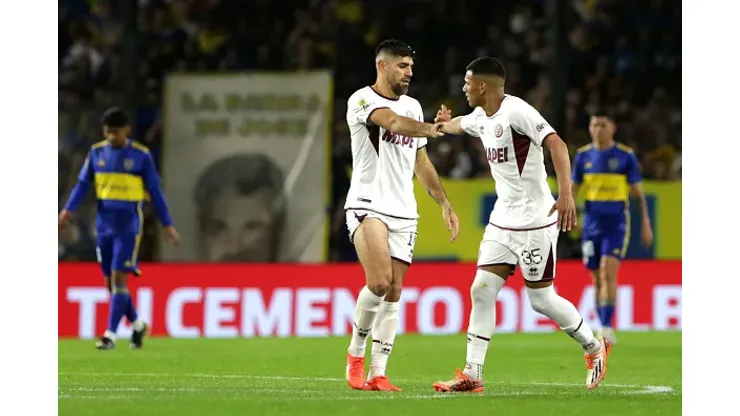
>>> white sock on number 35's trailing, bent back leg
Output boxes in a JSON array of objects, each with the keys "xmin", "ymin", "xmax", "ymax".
[{"xmin": 527, "ymin": 286, "xmax": 601, "ymax": 354}]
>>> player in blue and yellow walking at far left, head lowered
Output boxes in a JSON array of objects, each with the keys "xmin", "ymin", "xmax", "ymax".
[{"xmin": 59, "ymin": 107, "xmax": 179, "ymax": 350}]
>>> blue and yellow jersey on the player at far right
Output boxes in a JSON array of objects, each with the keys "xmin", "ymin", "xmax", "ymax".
[{"xmin": 572, "ymin": 143, "xmax": 642, "ymax": 216}]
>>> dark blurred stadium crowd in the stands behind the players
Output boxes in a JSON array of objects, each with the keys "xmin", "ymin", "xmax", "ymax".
[{"xmin": 59, "ymin": 0, "xmax": 681, "ymax": 261}]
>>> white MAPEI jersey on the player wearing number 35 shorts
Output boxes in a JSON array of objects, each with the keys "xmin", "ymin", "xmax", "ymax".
[{"xmin": 460, "ymin": 95, "xmax": 558, "ymax": 230}]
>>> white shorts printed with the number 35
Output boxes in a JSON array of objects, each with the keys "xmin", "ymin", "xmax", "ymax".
[{"xmin": 478, "ymin": 224, "xmax": 560, "ymax": 282}]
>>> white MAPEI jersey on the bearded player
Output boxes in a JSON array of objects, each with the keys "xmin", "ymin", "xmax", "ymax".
[{"xmin": 344, "ymin": 87, "xmax": 427, "ymax": 219}]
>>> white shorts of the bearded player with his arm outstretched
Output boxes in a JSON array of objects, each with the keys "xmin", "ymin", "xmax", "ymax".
[{"xmin": 345, "ymin": 209, "xmax": 418, "ymax": 265}]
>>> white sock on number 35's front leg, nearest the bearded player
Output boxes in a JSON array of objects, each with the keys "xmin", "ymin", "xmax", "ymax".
[{"xmin": 463, "ymin": 269, "xmax": 506, "ymax": 380}]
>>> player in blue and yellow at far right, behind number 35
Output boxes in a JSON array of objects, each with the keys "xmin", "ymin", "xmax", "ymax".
[{"xmin": 572, "ymin": 113, "xmax": 653, "ymax": 343}]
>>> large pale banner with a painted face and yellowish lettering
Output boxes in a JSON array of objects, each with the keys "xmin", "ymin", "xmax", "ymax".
[{"xmin": 160, "ymin": 71, "xmax": 333, "ymax": 263}]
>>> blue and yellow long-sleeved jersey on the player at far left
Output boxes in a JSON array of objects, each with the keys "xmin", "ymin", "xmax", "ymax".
[{"xmin": 65, "ymin": 140, "xmax": 172, "ymax": 235}]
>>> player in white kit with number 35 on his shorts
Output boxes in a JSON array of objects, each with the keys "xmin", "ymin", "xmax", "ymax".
[{"xmin": 434, "ymin": 57, "xmax": 611, "ymax": 392}]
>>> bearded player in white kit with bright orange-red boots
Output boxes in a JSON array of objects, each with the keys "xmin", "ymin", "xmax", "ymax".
[{"xmin": 344, "ymin": 40, "xmax": 459, "ymax": 391}]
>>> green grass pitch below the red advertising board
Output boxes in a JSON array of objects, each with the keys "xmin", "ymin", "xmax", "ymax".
[{"xmin": 59, "ymin": 332, "xmax": 681, "ymax": 416}]
